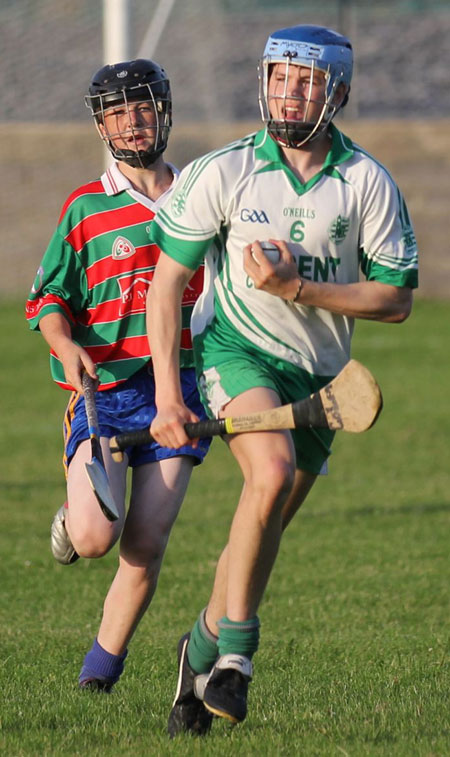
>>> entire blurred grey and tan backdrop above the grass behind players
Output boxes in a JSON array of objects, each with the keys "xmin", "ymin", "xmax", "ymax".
[{"xmin": 0, "ymin": 0, "xmax": 450, "ymax": 297}]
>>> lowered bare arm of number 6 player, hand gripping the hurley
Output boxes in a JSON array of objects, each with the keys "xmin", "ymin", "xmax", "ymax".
[{"xmin": 147, "ymin": 253, "xmax": 198, "ymax": 448}]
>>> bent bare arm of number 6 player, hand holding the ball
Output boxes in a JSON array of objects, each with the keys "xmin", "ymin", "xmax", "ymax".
[{"xmin": 244, "ymin": 240, "xmax": 413, "ymax": 323}]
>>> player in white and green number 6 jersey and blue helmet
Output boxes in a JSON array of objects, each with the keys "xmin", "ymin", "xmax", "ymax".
[{"xmin": 148, "ymin": 26, "xmax": 417, "ymax": 736}]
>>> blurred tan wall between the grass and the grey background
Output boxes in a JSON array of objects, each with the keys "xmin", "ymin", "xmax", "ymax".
[{"xmin": 0, "ymin": 119, "xmax": 450, "ymax": 299}]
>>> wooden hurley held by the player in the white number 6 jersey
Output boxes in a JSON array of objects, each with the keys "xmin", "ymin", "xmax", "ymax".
[{"xmin": 110, "ymin": 360, "xmax": 383, "ymax": 462}]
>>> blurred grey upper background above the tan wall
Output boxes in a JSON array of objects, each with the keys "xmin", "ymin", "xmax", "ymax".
[{"xmin": 0, "ymin": 0, "xmax": 450, "ymax": 123}]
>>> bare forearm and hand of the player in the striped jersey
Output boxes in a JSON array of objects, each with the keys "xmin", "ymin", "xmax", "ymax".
[{"xmin": 39, "ymin": 313, "xmax": 97, "ymax": 392}]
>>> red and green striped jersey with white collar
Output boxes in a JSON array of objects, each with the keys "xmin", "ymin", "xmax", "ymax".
[{"xmin": 26, "ymin": 164, "xmax": 203, "ymax": 389}]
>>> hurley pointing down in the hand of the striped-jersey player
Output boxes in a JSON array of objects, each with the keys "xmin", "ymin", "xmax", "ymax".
[{"xmin": 82, "ymin": 372, "xmax": 119, "ymax": 521}]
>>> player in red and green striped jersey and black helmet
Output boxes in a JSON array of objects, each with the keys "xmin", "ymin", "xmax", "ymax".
[{"xmin": 27, "ymin": 59, "xmax": 209, "ymax": 704}]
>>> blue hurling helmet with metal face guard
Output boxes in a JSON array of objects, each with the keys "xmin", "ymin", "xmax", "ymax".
[{"xmin": 258, "ymin": 24, "xmax": 353, "ymax": 148}]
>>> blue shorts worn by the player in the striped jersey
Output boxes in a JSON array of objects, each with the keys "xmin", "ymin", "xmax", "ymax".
[{"xmin": 63, "ymin": 363, "xmax": 211, "ymax": 473}]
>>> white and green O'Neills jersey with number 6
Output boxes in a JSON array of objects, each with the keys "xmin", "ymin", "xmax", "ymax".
[{"xmin": 150, "ymin": 126, "xmax": 417, "ymax": 376}]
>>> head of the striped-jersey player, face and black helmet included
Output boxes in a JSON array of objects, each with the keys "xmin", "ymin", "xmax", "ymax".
[{"xmin": 85, "ymin": 59, "xmax": 172, "ymax": 168}]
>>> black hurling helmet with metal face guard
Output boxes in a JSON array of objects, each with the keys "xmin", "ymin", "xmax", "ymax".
[{"xmin": 84, "ymin": 58, "xmax": 172, "ymax": 168}]
